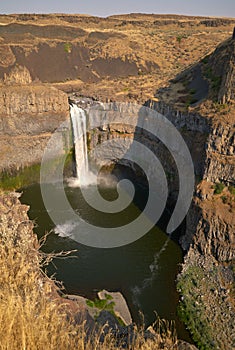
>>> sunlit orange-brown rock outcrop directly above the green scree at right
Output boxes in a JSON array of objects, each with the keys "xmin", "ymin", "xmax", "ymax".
[{"xmin": 180, "ymin": 189, "xmax": 235, "ymax": 262}]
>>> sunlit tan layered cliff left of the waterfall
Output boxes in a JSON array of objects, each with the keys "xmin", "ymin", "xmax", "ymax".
[{"xmin": 0, "ymin": 85, "xmax": 69, "ymax": 173}]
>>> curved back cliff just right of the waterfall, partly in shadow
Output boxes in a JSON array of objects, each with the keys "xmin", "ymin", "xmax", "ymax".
[{"xmin": 88, "ymin": 101, "xmax": 207, "ymax": 209}]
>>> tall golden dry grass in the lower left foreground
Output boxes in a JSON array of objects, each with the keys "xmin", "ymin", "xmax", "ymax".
[{"xmin": 0, "ymin": 194, "xmax": 177, "ymax": 350}]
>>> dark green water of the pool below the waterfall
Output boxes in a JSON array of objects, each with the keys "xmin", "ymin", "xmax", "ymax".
[{"xmin": 21, "ymin": 176, "xmax": 192, "ymax": 340}]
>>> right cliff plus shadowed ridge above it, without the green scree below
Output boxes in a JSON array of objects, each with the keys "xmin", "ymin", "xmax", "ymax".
[{"xmin": 148, "ymin": 39, "xmax": 235, "ymax": 261}]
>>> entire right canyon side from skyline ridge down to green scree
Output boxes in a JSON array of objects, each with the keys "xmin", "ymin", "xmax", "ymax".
[{"xmin": 149, "ymin": 39, "xmax": 235, "ymax": 350}]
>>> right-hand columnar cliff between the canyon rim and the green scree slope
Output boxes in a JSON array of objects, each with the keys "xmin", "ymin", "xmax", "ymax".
[{"xmin": 149, "ymin": 102, "xmax": 235, "ymax": 261}]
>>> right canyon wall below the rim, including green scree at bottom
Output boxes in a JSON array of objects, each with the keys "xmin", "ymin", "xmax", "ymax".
[{"xmin": 144, "ymin": 98, "xmax": 235, "ymax": 350}]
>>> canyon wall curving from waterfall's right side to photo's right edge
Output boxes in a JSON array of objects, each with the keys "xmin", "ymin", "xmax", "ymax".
[{"xmin": 88, "ymin": 101, "xmax": 235, "ymax": 261}]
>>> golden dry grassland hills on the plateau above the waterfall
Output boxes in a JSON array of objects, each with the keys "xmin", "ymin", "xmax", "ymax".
[{"xmin": 0, "ymin": 14, "xmax": 235, "ymax": 103}]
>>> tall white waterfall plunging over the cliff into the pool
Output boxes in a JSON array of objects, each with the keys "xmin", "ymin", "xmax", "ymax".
[{"xmin": 70, "ymin": 104, "xmax": 91, "ymax": 185}]
